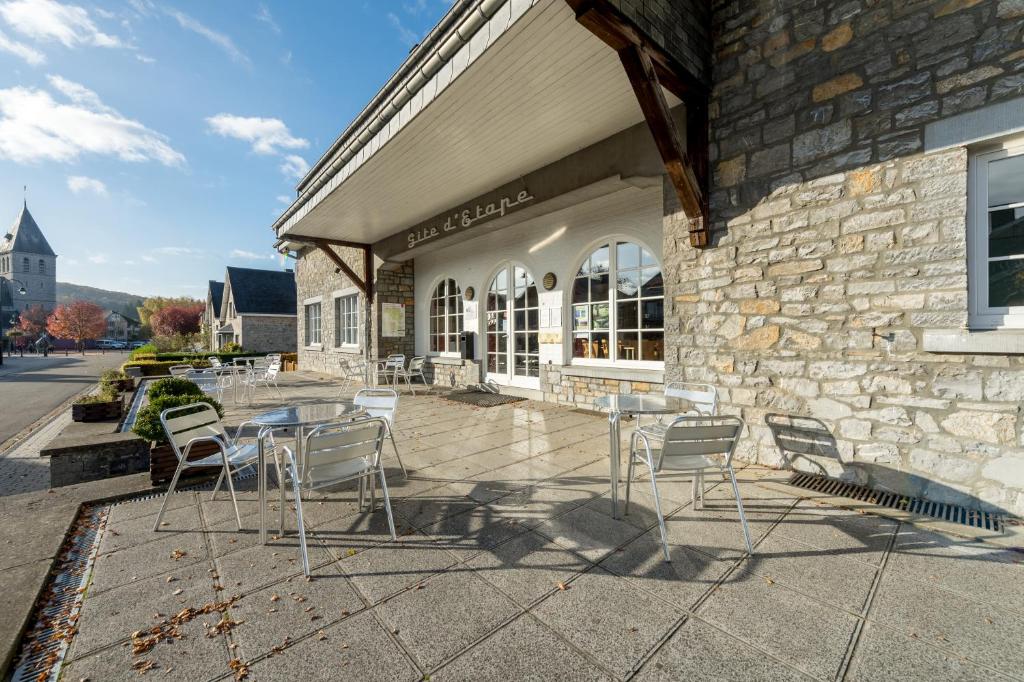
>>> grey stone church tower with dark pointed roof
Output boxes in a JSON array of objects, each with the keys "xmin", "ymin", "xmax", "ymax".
[{"xmin": 0, "ymin": 202, "xmax": 57, "ymax": 311}]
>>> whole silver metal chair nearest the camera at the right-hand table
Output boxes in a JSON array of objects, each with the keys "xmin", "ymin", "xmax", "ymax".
[{"xmin": 626, "ymin": 417, "xmax": 754, "ymax": 561}]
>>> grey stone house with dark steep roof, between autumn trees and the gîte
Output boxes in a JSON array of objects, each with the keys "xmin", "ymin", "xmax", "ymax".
[{"xmin": 216, "ymin": 267, "xmax": 296, "ymax": 352}]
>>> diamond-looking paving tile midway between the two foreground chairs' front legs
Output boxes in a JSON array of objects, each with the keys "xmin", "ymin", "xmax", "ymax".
[{"xmin": 466, "ymin": 531, "xmax": 590, "ymax": 606}]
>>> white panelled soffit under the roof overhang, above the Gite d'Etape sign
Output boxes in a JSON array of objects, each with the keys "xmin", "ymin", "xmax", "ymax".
[{"xmin": 280, "ymin": 0, "xmax": 678, "ymax": 244}]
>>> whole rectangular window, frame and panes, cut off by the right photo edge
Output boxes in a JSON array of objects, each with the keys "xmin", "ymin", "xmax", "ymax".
[{"xmin": 968, "ymin": 137, "xmax": 1024, "ymax": 329}]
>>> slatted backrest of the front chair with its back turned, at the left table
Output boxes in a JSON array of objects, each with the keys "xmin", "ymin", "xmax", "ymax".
[{"xmin": 299, "ymin": 417, "xmax": 387, "ymax": 488}]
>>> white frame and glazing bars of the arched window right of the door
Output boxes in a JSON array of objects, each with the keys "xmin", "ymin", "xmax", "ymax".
[{"xmin": 563, "ymin": 235, "xmax": 668, "ymax": 371}]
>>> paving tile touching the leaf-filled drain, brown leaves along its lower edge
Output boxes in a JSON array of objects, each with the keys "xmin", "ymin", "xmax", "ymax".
[{"xmin": 69, "ymin": 563, "xmax": 216, "ymax": 658}]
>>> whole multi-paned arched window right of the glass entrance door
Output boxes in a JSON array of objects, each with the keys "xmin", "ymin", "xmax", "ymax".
[{"xmin": 572, "ymin": 242, "xmax": 665, "ymax": 361}]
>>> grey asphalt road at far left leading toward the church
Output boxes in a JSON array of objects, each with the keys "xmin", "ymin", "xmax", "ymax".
[{"xmin": 0, "ymin": 350, "xmax": 128, "ymax": 452}]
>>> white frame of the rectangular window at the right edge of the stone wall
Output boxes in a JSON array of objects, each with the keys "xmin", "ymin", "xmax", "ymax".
[{"xmin": 967, "ymin": 137, "xmax": 1024, "ymax": 330}]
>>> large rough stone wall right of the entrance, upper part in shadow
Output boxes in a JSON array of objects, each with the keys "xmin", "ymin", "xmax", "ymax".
[{"xmin": 665, "ymin": 0, "xmax": 1024, "ymax": 513}]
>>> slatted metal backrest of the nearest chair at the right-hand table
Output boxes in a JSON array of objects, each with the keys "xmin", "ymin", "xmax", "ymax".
[{"xmin": 662, "ymin": 417, "xmax": 743, "ymax": 469}]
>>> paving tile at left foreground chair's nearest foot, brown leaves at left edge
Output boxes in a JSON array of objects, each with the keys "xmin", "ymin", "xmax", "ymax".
[{"xmin": 231, "ymin": 563, "xmax": 364, "ymax": 660}]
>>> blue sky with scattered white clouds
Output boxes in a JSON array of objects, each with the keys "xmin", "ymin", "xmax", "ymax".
[{"xmin": 0, "ymin": 0, "xmax": 452, "ymax": 298}]
